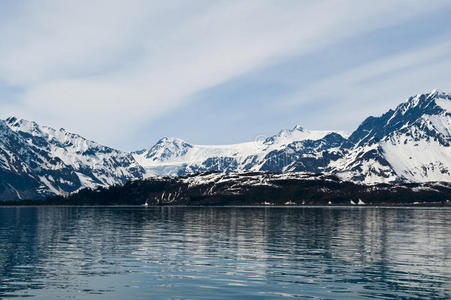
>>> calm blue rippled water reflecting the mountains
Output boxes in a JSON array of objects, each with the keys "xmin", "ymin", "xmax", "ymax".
[{"xmin": 0, "ymin": 207, "xmax": 451, "ymax": 299}]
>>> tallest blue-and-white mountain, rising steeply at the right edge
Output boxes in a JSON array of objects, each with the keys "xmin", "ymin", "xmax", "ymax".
[{"xmin": 329, "ymin": 90, "xmax": 451, "ymax": 183}]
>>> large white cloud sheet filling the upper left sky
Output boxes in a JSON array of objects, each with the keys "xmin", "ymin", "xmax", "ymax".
[{"xmin": 0, "ymin": 0, "xmax": 447, "ymax": 148}]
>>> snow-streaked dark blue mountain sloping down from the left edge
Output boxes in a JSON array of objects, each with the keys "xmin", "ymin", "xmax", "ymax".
[{"xmin": 0, "ymin": 117, "xmax": 144, "ymax": 199}]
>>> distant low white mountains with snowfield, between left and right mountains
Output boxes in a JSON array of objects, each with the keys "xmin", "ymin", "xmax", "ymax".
[{"xmin": 133, "ymin": 126, "xmax": 345, "ymax": 176}]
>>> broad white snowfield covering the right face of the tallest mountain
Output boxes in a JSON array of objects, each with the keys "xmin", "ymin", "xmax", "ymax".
[{"xmin": 381, "ymin": 91, "xmax": 451, "ymax": 182}]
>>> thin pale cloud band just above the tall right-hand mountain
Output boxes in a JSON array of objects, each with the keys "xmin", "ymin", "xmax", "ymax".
[{"xmin": 281, "ymin": 39, "xmax": 451, "ymax": 127}]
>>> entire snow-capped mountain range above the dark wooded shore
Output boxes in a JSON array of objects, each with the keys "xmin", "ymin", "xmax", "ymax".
[{"xmin": 0, "ymin": 90, "xmax": 451, "ymax": 200}]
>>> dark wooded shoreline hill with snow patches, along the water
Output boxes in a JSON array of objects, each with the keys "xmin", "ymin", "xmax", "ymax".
[{"xmin": 1, "ymin": 173, "xmax": 451, "ymax": 206}]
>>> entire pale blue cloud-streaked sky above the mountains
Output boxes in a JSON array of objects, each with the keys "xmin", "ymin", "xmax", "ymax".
[{"xmin": 0, "ymin": 0, "xmax": 451, "ymax": 151}]
